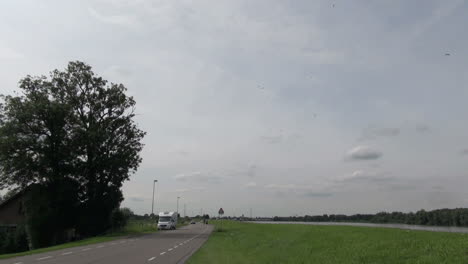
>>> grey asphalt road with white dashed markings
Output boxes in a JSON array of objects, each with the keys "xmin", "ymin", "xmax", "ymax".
[{"xmin": 0, "ymin": 223, "xmax": 213, "ymax": 264}]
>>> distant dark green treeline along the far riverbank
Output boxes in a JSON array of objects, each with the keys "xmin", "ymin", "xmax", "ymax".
[{"xmin": 273, "ymin": 208, "xmax": 468, "ymax": 227}]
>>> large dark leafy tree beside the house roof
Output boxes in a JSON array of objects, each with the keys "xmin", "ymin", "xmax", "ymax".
[{"xmin": 0, "ymin": 61, "xmax": 145, "ymax": 237}]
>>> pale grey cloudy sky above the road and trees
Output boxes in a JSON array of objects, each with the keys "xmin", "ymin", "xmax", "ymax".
[{"xmin": 0, "ymin": 0, "xmax": 468, "ymax": 216}]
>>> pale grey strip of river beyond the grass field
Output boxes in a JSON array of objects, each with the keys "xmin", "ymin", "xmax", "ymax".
[{"xmin": 251, "ymin": 221, "xmax": 468, "ymax": 233}]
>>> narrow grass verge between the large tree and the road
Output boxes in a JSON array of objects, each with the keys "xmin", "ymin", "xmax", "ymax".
[{"xmin": 0, "ymin": 220, "xmax": 158, "ymax": 259}]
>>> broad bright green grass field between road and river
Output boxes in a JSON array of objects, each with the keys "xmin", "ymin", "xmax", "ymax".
[{"xmin": 188, "ymin": 221, "xmax": 468, "ymax": 264}]
